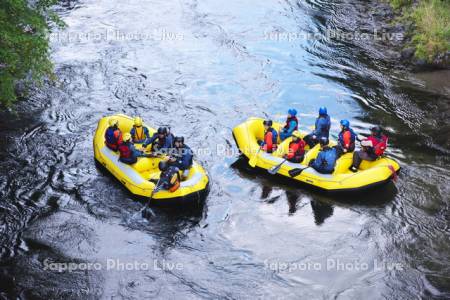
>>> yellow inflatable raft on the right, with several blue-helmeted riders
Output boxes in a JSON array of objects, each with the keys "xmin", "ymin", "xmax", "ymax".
[{"xmin": 233, "ymin": 118, "xmax": 400, "ymax": 191}]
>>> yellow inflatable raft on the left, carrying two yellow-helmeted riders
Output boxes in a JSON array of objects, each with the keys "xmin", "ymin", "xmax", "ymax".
[{"xmin": 94, "ymin": 114, "xmax": 208, "ymax": 204}]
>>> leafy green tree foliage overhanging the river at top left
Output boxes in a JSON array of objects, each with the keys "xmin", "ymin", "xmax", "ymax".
[{"xmin": 0, "ymin": 0, "xmax": 63, "ymax": 107}]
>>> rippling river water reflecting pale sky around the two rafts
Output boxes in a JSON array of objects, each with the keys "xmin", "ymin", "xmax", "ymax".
[{"xmin": 0, "ymin": 0, "xmax": 450, "ymax": 299}]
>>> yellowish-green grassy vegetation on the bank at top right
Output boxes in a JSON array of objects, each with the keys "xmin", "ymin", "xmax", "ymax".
[{"xmin": 390, "ymin": 0, "xmax": 450, "ymax": 62}]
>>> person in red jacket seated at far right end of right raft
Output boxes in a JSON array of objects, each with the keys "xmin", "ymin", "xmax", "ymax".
[{"xmin": 349, "ymin": 126, "xmax": 388, "ymax": 172}]
